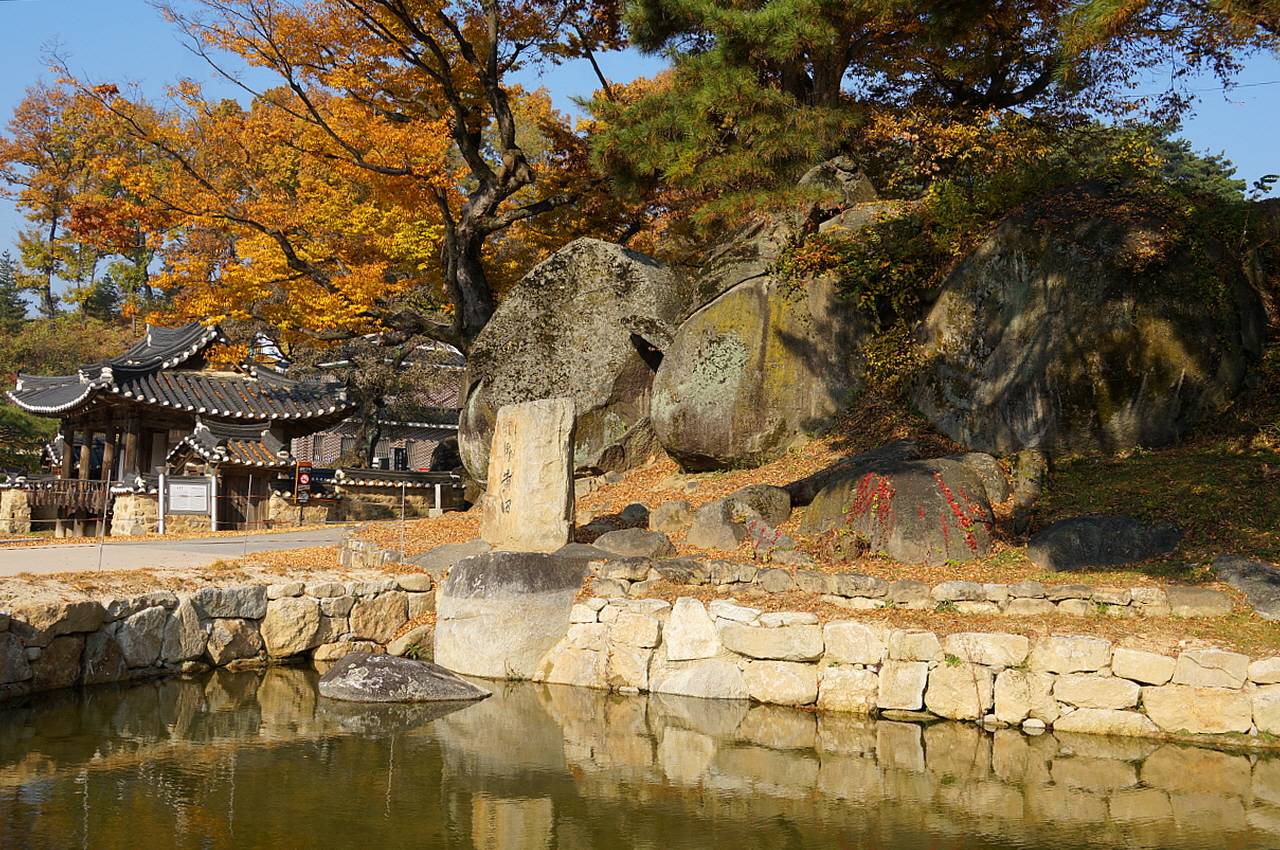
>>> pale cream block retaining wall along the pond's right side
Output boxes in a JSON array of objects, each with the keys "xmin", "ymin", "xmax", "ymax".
[{"xmin": 536, "ymin": 597, "xmax": 1280, "ymax": 737}]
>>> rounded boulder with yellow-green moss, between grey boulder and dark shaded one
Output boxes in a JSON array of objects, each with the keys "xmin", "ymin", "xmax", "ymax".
[{"xmin": 650, "ymin": 275, "xmax": 867, "ymax": 471}]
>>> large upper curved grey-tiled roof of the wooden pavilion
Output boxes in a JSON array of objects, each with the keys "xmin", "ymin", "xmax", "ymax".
[{"xmin": 8, "ymin": 325, "xmax": 355, "ymax": 420}]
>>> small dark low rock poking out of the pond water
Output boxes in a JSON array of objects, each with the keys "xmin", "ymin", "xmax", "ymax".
[{"xmin": 320, "ymin": 653, "xmax": 492, "ymax": 703}]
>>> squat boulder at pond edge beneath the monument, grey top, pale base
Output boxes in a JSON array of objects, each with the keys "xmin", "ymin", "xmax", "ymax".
[{"xmin": 435, "ymin": 552, "xmax": 588, "ymax": 678}]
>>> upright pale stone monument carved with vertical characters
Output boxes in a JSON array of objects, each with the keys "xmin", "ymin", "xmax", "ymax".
[{"xmin": 480, "ymin": 398, "xmax": 576, "ymax": 552}]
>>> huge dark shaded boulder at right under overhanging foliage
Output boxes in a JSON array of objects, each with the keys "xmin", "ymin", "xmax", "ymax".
[{"xmin": 911, "ymin": 183, "xmax": 1263, "ymax": 456}]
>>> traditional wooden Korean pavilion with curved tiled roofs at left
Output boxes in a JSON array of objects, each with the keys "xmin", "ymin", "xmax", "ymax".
[{"xmin": 9, "ymin": 324, "xmax": 356, "ymax": 535}]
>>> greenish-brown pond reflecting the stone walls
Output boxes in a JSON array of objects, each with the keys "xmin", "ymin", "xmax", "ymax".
[{"xmin": 0, "ymin": 668, "xmax": 1280, "ymax": 850}]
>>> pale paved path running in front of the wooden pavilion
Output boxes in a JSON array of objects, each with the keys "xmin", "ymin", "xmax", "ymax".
[{"xmin": 0, "ymin": 526, "xmax": 347, "ymax": 576}]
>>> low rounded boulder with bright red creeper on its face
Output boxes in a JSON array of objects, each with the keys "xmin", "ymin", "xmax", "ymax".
[{"xmin": 800, "ymin": 458, "xmax": 993, "ymax": 565}]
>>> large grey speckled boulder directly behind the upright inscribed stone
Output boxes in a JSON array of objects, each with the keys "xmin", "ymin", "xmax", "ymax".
[{"xmin": 458, "ymin": 239, "xmax": 700, "ymax": 484}]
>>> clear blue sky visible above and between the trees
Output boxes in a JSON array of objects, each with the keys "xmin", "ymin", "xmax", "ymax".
[{"xmin": 0, "ymin": 0, "xmax": 1280, "ymax": 266}]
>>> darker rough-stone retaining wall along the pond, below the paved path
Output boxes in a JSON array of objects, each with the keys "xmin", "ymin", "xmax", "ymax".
[{"xmin": 0, "ymin": 572, "xmax": 436, "ymax": 699}]
